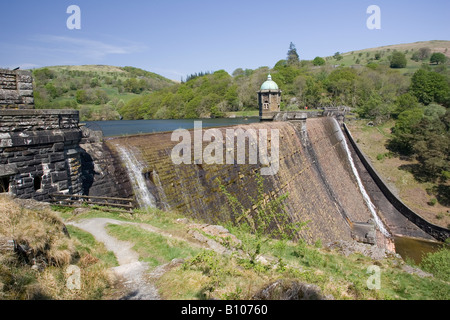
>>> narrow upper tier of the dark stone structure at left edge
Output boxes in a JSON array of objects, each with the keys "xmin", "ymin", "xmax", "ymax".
[{"xmin": 0, "ymin": 69, "xmax": 34, "ymax": 109}]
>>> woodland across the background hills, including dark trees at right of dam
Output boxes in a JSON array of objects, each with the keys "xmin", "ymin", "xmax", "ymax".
[{"xmin": 34, "ymin": 43, "xmax": 450, "ymax": 185}]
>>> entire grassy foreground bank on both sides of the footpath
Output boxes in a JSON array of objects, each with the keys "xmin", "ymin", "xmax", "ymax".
[{"xmin": 0, "ymin": 198, "xmax": 450, "ymax": 300}]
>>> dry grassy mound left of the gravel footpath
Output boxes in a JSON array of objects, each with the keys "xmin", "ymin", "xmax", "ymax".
[{"xmin": 0, "ymin": 195, "xmax": 117, "ymax": 300}]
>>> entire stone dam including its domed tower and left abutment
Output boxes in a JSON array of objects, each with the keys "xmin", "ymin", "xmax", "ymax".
[{"xmin": 0, "ymin": 70, "xmax": 450, "ymax": 249}]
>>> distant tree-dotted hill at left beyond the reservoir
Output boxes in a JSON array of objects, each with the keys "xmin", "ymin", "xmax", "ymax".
[{"xmin": 33, "ymin": 65, "xmax": 175, "ymax": 121}]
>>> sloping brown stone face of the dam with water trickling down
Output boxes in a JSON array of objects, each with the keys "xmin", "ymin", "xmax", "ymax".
[{"xmin": 107, "ymin": 117, "xmax": 446, "ymax": 246}]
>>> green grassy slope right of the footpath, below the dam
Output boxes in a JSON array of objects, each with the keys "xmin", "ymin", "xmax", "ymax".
[{"xmin": 49, "ymin": 205, "xmax": 450, "ymax": 300}]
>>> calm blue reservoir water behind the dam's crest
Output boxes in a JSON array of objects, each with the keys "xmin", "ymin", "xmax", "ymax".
[{"xmin": 82, "ymin": 117, "xmax": 259, "ymax": 137}]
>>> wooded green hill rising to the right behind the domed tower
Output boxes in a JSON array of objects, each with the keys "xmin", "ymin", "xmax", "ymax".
[{"xmin": 119, "ymin": 41, "xmax": 450, "ymax": 122}]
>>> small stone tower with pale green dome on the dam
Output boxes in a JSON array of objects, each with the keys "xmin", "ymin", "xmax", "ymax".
[{"xmin": 258, "ymin": 74, "xmax": 281, "ymax": 121}]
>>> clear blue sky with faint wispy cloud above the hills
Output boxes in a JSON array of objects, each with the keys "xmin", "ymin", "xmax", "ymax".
[{"xmin": 0, "ymin": 0, "xmax": 450, "ymax": 80}]
